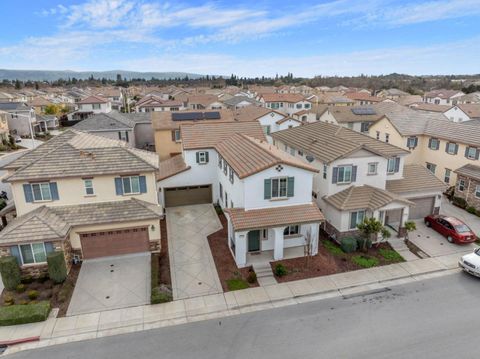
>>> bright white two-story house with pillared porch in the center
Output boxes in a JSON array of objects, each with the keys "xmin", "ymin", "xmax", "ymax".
[{"xmin": 158, "ymin": 122, "xmax": 323, "ymax": 267}]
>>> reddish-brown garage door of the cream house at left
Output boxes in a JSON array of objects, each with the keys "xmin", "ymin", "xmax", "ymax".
[{"xmin": 80, "ymin": 227, "xmax": 149, "ymax": 259}]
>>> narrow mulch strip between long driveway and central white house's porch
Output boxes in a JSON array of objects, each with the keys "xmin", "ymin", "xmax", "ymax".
[{"xmin": 207, "ymin": 214, "xmax": 258, "ymax": 292}]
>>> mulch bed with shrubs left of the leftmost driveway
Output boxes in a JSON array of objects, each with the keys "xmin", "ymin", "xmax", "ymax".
[{"xmin": 0, "ymin": 264, "xmax": 81, "ymax": 317}]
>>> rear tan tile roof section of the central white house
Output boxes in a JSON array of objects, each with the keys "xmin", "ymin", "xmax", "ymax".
[{"xmin": 180, "ymin": 121, "xmax": 266, "ymax": 150}]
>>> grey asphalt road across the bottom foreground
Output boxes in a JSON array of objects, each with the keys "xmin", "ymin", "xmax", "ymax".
[{"xmin": 8, "ymin": 273, "xmax": 480, "ymax": 359}]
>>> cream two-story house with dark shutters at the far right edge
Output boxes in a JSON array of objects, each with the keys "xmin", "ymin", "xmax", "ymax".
[{"xmin": 369, "ymin": 103, "xmax": 480, "ymax": 185}]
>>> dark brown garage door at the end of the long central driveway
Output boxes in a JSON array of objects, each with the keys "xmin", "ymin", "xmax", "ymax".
[{"xmin": 165, "ymin": 185, "xmax": 212, "ymax": 207}]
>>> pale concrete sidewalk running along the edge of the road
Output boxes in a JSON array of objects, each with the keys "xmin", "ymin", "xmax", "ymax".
[{"xmin": 0, "ymin": 254, "xmax": 459, "ymax": 353}]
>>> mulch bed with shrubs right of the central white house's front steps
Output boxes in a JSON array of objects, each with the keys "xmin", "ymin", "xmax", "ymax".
[{"xmin": 270, "ymin": 237, "xmax": 404, "ymax": 283}]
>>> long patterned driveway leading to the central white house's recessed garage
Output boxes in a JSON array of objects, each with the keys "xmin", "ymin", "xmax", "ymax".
[{"xmin": 166, "ymin": 204, "xmax": 223, "ymax": 299}]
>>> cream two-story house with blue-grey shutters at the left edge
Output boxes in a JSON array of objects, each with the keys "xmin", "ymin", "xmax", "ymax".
[{"xmin": 0, "ymin": 130, "xmax": 163, "ymax": 274}]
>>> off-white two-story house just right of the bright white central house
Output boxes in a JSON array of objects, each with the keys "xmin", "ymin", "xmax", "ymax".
[{"xmin": 272, "ymin": 122, "xmax": 443, "ymax": 239}]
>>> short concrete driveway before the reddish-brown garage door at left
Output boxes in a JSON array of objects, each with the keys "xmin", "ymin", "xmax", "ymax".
[{"xmin": 67, "ymin": 253, "xmax": 151, "ymax": 316}]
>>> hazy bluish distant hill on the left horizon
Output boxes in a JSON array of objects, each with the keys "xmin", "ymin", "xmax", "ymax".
[{"xmin": 0, "ymin": 69, "xmax": 203, "ymax": 81}]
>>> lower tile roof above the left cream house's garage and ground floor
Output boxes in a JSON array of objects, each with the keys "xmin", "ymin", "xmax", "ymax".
[{"xmin": 0, "ymin": 198, "xmax": 163, "ymax": 245}]
